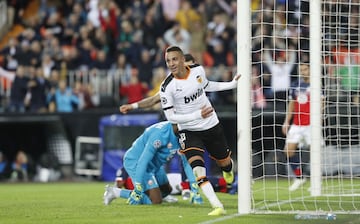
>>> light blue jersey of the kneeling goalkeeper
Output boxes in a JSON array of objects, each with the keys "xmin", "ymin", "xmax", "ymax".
[{"xmin": 124, "ymin": 121, "xmax": 180, "ymax": 183}]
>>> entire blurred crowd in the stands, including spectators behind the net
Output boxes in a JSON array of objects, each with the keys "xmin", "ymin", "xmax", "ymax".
[{"xmin": 0, "ymin": 0, "xmax": 360, "ymax": 115}]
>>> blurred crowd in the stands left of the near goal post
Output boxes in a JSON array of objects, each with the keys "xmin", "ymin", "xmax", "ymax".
[{"xmin": 0, "ymin": 0, "xmax": 236, "ymax": 112}]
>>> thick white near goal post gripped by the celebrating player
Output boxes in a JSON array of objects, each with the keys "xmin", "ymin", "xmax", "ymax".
[{"xmin": 237, "ymin": 0, "xmax": 251, "ymax": 214}]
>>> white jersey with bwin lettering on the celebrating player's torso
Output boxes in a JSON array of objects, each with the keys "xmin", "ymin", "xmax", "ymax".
[{"xmin": 160, "ymin": 65, "xmax": 219, "ymax": 131}]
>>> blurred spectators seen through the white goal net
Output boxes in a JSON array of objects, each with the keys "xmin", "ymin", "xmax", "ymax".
[{"xmin": 252, "ymin": 0, "xmax": 360, "ymax": 108}]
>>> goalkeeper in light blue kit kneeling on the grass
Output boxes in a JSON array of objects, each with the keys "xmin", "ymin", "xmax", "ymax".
[{"xmin": 103, "ymin": 121, "xmax": 203, "ymax": 205}]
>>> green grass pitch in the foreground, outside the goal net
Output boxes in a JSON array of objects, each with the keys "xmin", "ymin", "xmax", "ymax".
[{"xmin": 0, "ymin": 182, "xmax": 360, "ymax": 224}]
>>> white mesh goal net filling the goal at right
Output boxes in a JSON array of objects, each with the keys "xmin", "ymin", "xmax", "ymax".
[{"xmin": 238, "ymin": 0, "xmax": 360, "ymax": 213}]
